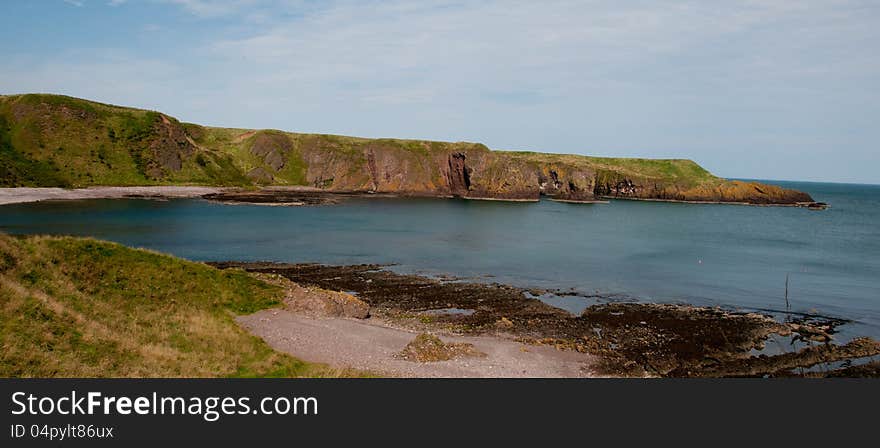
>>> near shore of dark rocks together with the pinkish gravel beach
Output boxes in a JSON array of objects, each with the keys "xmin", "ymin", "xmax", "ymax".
[{"xmin": 208, "ymin": 262, "xmax": 880, "ymax": 377}]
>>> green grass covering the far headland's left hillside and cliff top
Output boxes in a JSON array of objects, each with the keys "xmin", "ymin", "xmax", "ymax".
[{"xmin": 0, "ymin": 94, "xmax": 720, "ymax": 186}]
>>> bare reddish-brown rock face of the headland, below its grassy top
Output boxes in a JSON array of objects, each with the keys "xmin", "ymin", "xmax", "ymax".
[{"xmin": 272, "ymin": 136, "xmax": 812, "ymax": 204}]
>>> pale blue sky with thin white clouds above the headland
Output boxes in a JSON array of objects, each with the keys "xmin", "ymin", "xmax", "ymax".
[{"xmin": 0, "ymin": 0, "xmax": 880, "ymax": 184}]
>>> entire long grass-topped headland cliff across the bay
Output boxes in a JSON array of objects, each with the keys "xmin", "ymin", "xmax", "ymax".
[{"xmin": 0, "ymin": 94, "xmax": 812, "ymax": 204}]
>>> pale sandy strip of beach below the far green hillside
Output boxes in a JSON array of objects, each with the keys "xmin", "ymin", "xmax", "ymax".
[{"xmin": 0, "ymin": 186, "xmax": 225, "ymax": 205}]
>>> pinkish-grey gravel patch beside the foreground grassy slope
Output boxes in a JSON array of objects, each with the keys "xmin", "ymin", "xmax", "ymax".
[{"xmin": 237, "ymin": 309, "xmax": 596, "ymax": 378}]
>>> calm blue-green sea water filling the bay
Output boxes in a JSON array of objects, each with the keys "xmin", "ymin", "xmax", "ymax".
[{"xmin": 0, "ymin": 181, "xmax": 880, "ymax": 337}]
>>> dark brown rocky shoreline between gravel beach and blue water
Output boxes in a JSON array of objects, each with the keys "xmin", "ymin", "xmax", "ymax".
[{"xmin": 211, "ymin": 262, "xmax": 880, "ymax": 377}]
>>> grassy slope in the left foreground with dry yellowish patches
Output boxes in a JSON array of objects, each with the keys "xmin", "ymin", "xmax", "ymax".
[{"xmin": 0, "ymin": 234, "xmax": 353, "ymax": 377}]
